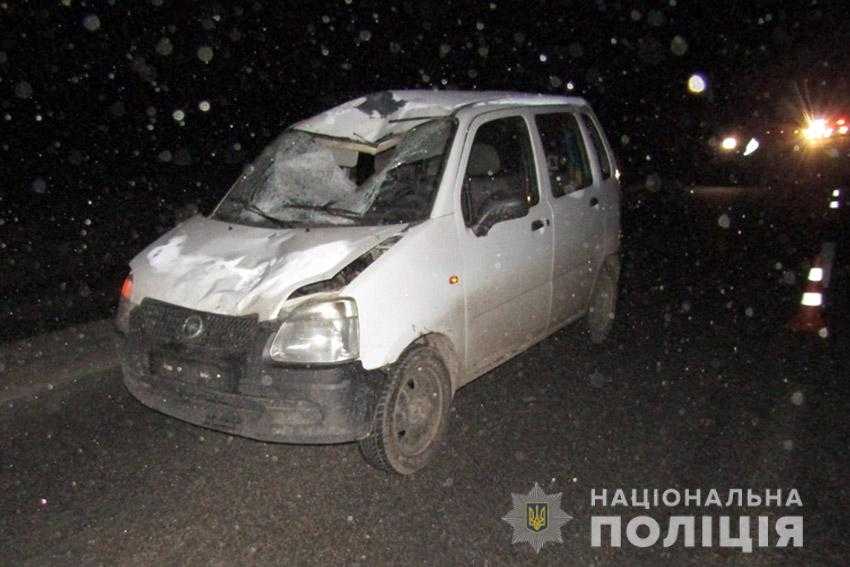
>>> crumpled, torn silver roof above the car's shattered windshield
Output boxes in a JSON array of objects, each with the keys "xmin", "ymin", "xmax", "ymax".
[{"xmin": 293, "ymin": 90, "xmax": 586, "ymax": 146}]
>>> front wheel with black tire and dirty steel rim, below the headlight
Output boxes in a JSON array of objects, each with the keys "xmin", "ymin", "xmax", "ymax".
[{"xmin": 360, "ymin": 345, "xmax": 452, "ymax": 474}]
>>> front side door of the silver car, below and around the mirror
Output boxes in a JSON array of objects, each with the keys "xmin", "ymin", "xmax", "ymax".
[{"xmin": 458, "ymin": 111, "xmax": 553, "ymax": 374}]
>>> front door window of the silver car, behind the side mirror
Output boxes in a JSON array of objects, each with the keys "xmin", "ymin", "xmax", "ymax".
[{"xmin": 461, "ymin": 116, "xmax": 539, "ymax": 226}]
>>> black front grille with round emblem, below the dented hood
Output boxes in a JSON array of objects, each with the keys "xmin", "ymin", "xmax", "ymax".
[{"xmin": 130, "ymin": 298, "xmax": 259, "ymax": 355}]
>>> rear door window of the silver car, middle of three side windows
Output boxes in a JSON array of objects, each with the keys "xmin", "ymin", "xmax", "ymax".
[{"xmin": 534, "ymin": 113, "xmax": 593, "ymax": 197}]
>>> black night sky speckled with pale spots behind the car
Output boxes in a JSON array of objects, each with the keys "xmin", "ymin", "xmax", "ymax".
[{"xmin": 0, "ymin": 0, "xmax": 850, "ymax": 338}]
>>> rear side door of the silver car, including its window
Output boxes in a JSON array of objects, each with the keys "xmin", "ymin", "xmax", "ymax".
[{"xmin": 534, "ymin": 109, "xmax": 604, "ymax": 327}]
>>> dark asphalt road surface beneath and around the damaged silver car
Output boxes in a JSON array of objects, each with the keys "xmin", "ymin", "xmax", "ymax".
[{"xmin": 0, "ymin": 184, "xmax": 848, "ymax": 565}]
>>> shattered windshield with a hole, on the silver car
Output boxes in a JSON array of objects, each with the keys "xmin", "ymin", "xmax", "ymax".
[{"xmin": 213, "ymin": 118, "xmax": 454, "ymax": 227}]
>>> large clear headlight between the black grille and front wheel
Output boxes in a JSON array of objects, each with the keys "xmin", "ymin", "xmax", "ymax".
[{"xmin": 266, "ymin": 298, "xmax": 360, "ymax": 364}]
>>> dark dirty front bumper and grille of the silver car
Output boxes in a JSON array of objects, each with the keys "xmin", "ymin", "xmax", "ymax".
[{"xmin": 118, "ymin": 299, "xmax": 384, "ymax": 443}]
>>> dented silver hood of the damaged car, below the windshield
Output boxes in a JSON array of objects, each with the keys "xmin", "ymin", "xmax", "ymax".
[{"xmin": 130, "ymin": 216, "xmax": 404, "ymax": 319}]
